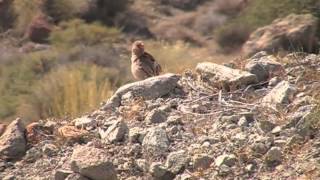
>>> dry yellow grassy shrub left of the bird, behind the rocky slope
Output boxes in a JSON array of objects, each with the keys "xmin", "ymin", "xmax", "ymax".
[{"xmin": 19, "ymin": 64, "xmax": 119, "ymax": 118}]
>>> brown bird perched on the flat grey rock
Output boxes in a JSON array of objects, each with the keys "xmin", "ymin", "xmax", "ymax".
[{"xmin": 131, "ymin": 41, "xmax": 162, "ymax": 80}]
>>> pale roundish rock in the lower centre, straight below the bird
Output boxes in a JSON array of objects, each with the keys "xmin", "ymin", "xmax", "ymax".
[{"xmin": 142, "ymin": 128, "xmax": 169, "ymax": 155}]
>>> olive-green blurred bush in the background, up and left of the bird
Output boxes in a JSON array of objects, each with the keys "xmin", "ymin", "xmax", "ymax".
[{"xmin": 49, "ymin": 19, "xmax": 120, "ymax": 48}]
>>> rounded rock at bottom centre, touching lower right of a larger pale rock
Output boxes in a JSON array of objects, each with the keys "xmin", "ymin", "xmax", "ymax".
[{"xmin": 166, "ymin": 150, "xmax": 190, "ymax": 174}]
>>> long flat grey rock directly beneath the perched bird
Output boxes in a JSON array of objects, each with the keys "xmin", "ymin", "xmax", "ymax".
[{"xmin": 102, "ymin": 73, "xmax": 180, "ymax": 110}]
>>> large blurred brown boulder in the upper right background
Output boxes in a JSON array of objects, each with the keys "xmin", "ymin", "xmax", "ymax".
[{"xmin": 243, "ymin": 14, "xmax": 318, "ymax": 56}]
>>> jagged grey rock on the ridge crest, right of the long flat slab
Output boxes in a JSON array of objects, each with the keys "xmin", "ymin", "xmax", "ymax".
[{"xmin": 245, "ymin": 52, "xmax": 284, "ymax": 82}]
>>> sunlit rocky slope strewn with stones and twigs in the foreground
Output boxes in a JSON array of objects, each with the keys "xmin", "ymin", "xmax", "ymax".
[{"xmin": 0, "ymin": 52, "xmax": 320, "ymax": 180}]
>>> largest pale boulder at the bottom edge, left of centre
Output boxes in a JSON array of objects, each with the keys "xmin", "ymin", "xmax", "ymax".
[{"xmin": 71, "ymin": 146, "xmax": 117, "ymax": 180}]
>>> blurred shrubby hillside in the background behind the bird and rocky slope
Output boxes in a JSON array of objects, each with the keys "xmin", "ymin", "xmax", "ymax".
[{"xmin": 0, "ymin": 0, "xmax": 320, "ymax": 121}]
